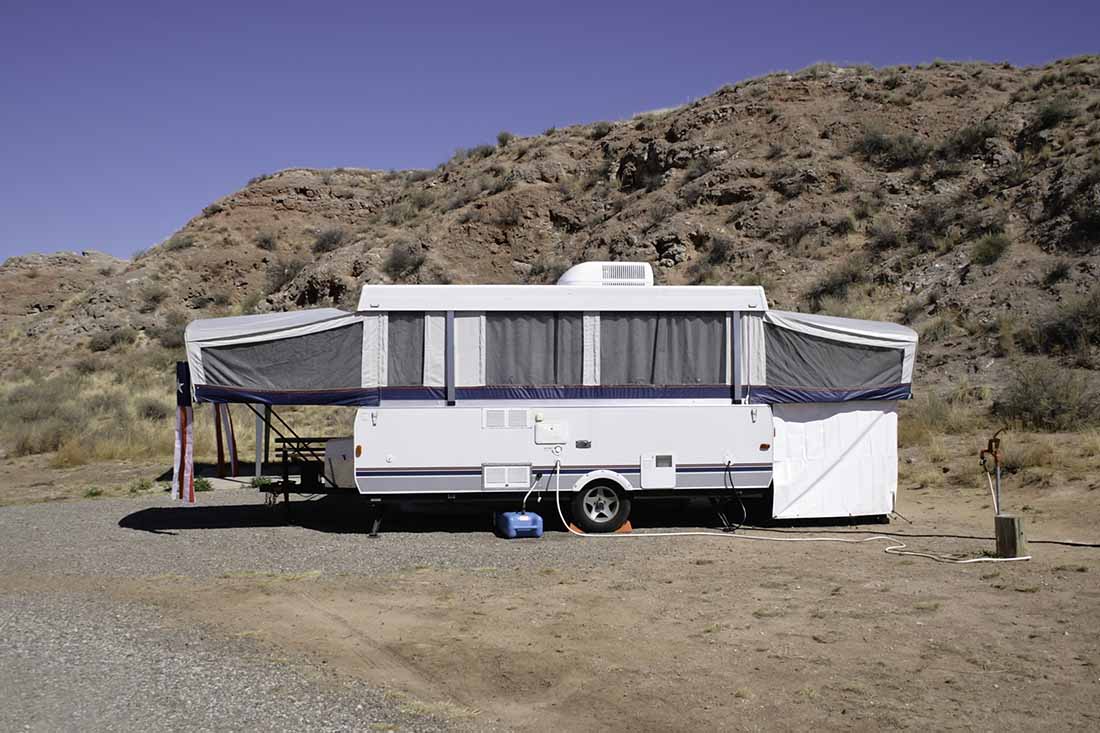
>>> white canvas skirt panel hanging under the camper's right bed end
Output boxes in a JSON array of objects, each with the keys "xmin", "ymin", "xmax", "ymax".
[{"xmin": 772, "ymin": 402, "xmax": 898, "ymax": 518}]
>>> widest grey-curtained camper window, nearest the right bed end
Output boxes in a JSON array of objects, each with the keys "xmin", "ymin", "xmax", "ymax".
[{"xmin": 600, "ymin": 311, "xmax": 726, "ymax": 385}]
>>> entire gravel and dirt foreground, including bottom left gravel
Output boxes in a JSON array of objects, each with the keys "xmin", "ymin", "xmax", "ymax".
[{"xmin": 8, "ymin": 489, "xmax": 1086, "ymax": 731}]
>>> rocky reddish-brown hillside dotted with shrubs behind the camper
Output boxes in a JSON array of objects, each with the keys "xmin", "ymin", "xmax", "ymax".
[{"xmin": 0, "ymin": 57, "xmax": 1100, "ymax": 382}]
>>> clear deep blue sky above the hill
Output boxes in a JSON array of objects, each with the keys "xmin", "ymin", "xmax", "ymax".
[{"xmin": 0, "ymin": 0, "xmax": 1100, "ymax": 258}]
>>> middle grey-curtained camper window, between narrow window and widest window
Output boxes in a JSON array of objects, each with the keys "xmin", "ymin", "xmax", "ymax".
[{"xmin": 485, "ymin": 313, "xmax": 584, "ymax": 386}]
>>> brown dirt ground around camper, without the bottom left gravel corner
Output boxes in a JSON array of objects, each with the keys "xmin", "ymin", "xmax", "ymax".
[{"xmin": 0, "ymin": 449, "xmax": 1100, "ymax": 731}]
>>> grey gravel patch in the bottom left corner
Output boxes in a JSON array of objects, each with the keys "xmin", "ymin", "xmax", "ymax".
[{"xmin": 0, "ymin": 593, "xmax": 455, "ymax": 731}]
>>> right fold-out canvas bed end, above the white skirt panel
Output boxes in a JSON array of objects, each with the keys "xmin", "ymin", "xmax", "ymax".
[{"xmin": 741, "ymin": 310, "xmax": 916, "ymax": 404}]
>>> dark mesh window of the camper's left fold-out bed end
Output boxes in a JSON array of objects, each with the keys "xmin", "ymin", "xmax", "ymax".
[{"xmin": 202, "ymin": 324, "xmax": 363, "ymax": 391}]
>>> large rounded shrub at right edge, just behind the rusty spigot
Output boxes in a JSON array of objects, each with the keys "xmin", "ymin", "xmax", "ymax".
[{"xmin": 993, "ymin": 361, "xmax": 1100, "ymax": 430}]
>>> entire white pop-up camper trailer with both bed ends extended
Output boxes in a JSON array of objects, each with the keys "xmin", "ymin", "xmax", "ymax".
[{"xmin": 186, "ymin": 262, "xmax": 916, "ymax": 532}]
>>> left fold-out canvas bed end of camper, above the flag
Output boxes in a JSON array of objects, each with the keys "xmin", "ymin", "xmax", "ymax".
[{"xmin": 185, "ymin": 308, "xmax": 378, "ymax": 405}]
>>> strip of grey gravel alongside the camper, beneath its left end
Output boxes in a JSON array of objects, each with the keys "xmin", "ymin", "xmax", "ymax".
[{"xmin": 0, "ymin": 489, "xmax": 783, "ymax": 577}]
